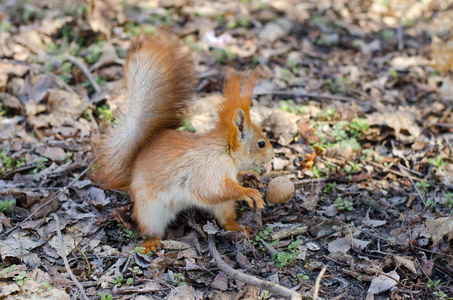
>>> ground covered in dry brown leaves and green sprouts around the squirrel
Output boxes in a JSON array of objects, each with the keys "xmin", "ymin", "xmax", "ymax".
[{"xmin": 0, "ymin": 0, "xmax": 453, "ymax": 299}]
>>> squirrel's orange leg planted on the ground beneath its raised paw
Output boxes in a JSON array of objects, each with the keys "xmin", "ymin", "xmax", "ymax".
[{"xmin": 209, "ymin": 201, "xmax": 252, "ymax": 238}]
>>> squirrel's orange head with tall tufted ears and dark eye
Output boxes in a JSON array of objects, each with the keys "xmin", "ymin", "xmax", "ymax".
[{"xmin": 216, "ymin": 70, "xmax": 274, "ymax": 170}]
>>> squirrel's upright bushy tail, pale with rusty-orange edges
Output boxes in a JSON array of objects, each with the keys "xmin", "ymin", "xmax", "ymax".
[{"xmin": 95, "ymin": 33, "xmax": 195, "ymax": 190}]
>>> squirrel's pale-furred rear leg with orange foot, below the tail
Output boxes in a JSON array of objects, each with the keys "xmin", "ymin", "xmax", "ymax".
[{"xmin": 131, "ymin": 189, "xmax": 176, "ymax": 254}]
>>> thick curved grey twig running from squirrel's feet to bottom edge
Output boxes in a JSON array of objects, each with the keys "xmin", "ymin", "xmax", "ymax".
[{"xmin": 208, "ymin": 234, "xmax": 309, "ymax": 300}]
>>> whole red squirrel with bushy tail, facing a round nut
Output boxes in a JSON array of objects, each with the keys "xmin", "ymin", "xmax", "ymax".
[{"xmin": 95, "ymin": 33, "xmax": 274, "ymax": 253}]
